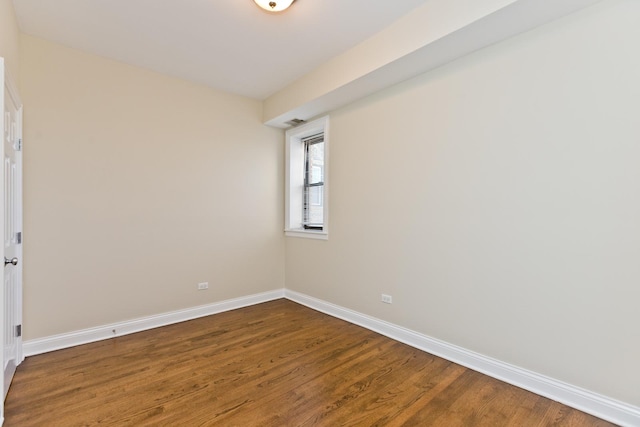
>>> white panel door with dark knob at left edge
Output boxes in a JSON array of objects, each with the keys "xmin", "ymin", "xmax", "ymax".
[{"xmin": 2, "ymin": 59, "xmax": 22, "ymax": 400}]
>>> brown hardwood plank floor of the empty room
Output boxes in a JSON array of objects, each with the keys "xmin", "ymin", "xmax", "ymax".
[{"xmin": 5, "ymin": 300, "xmax": 612, "ymax": 427}]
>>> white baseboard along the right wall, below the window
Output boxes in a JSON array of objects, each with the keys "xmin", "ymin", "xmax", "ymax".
[{"xmin": 284, "ymin": 290, "xmax": 640, "ymax": 427}]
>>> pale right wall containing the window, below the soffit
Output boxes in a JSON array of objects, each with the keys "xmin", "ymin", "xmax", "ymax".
[{"xmin": 286, "ymin": 0, "xmax": 640, "ymax": 405}]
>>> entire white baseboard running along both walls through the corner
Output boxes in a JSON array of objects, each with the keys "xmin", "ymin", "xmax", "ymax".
[{"xmin": 20, "ymin": 289, "xmax": 640, "ymax": 427}]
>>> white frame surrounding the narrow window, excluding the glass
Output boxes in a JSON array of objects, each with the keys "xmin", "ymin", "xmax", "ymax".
[{"xmin": 284, "ymin": 116, "xmax": 329, "ymax": 240}]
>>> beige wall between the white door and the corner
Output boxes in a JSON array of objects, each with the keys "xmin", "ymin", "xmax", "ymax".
[{"xmin": 21, "ymin": 36, "xmax": 284, "ymax": 340}]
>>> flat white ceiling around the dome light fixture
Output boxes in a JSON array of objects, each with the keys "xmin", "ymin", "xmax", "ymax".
[{"xmin": 13, "ymin": 0, "xmax": 429, "ymax": 99}]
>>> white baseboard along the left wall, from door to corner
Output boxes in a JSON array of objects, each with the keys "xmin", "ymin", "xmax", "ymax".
[{"xmin": 22, "ymin": 289, "xmax": 284, "ymax": 356}]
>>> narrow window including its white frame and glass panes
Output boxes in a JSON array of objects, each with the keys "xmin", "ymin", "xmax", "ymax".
[{"xmin": 285, "ymin": 117, "xmax": 329, "ymax": 239}]
